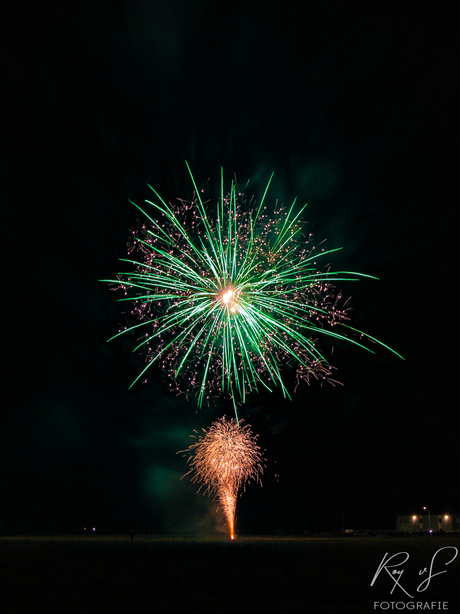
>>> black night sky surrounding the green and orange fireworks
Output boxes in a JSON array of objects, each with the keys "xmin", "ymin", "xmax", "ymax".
[{"xmin": 0, "ymin": 0, "xmax": 460, "ymax": 534}]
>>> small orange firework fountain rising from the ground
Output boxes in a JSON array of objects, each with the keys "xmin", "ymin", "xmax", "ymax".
[{"xmin": 182, "ymin": 417, "xmax": 264, "ymax": 539}]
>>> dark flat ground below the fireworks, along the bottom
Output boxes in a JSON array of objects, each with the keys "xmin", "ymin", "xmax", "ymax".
[{"xmin": 0, "ymin": 536, "xmax": 460, "ymax": 614}]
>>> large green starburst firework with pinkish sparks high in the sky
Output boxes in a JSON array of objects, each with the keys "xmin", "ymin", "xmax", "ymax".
[{"xmin": 104, "ymin": 165, "xmax": 393, "ymax": 416}]
